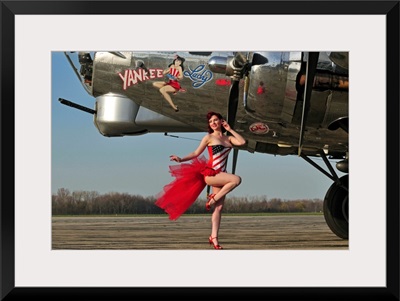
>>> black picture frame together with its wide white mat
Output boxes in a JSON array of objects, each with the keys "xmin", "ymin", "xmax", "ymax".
[{"xmin": 0, "ymin": 1, "xmax": 400, "ymax": 300}]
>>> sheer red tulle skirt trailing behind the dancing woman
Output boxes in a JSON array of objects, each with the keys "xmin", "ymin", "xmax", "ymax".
[{"xmin": 155, "ymin": 156, "xmax": 219, "ymax": 220}]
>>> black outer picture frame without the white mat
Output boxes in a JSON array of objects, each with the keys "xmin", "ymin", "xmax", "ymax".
[{"xmin": 0, "ymin": 1, "xmax": 400, "ymax": 300}]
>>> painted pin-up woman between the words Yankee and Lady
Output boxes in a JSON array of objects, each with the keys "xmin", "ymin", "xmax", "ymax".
[{"xmin": 153, "ymin": 56, "xmax": 185, "ymax": 112}]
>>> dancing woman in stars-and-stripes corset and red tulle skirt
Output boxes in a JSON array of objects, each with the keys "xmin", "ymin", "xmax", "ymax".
[{"xmin": 156, "ymin": 112, "xmax": 246, "ymax": 250}]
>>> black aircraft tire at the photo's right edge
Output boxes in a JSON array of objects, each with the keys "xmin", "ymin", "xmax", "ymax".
[{"xmin": 324, "ymin": 175, "xmax": 349, "ymax": 239}]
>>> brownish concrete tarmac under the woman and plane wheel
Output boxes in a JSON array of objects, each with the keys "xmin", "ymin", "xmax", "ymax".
[{"xmin": 52, "ymin": 214, "xmax": 349, "ymax": 250}]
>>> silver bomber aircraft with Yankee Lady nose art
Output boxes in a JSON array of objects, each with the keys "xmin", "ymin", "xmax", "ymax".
[{"xmin": 59, "ymin": 51, "xmax": 349, "ymax": 239}]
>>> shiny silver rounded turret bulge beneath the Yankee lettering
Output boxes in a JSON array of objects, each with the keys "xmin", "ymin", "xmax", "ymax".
[{"xmin": 93, "ymin": 93, "xmax": 200, "ymax": 137}]
